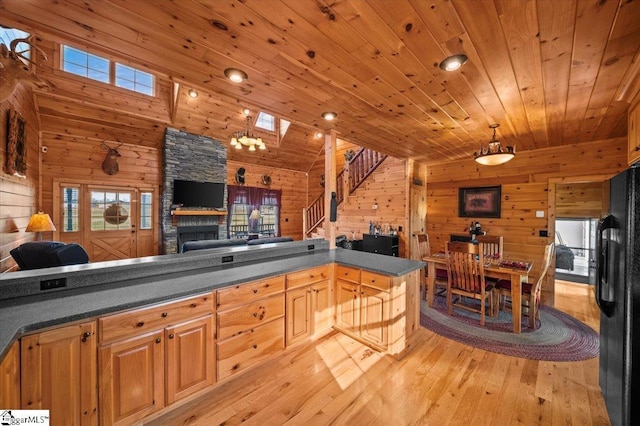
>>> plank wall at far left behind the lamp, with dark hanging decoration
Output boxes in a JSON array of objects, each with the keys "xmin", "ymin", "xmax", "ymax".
[{"xmin": 0, "ymin": 85, "xmax": 39, "ymax": 272}]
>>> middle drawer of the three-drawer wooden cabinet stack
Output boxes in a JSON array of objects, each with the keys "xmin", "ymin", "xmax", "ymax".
[{"xmin": 218, "ymin": 293, "xmax": 284, "ymax": 339}]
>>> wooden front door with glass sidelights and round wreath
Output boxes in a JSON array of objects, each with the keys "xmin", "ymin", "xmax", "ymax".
[{"xmin": 54, "ymin": 183, "xmax": 158, "ymax": 262}]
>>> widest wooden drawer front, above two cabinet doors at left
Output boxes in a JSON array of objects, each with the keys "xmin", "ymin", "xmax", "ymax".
[{"xmin": 98, "ymin": 293, "xmax": 213, "ymax": 342}]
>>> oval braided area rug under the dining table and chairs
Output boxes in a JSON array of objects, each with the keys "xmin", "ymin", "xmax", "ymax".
[{"xmin": 420, "ymin": 296, "xmax": 599, "ymax": 361}]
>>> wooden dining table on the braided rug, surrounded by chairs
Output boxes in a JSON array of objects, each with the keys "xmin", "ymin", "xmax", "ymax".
[{"xmin": 422, "ymin": 253, "xmax": 533, "ymax": 333}]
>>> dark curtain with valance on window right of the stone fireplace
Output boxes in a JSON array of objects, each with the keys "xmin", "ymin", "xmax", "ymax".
[{"xmin": 227, "ymin": 185, "xmax": 282, "ymax": 236}]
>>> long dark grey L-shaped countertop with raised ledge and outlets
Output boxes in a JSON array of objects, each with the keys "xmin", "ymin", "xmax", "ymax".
[{"xmin": 0, "ymin": 240, "xmax": 425, "ymax": 361}]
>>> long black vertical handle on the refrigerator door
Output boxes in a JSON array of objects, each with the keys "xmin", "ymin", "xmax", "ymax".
[{"xmin": 595, "ymin": 215, "xmax": 616, "ymax": 316}]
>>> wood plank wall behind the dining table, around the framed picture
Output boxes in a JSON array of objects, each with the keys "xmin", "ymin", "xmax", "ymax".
[{"xmin": 426, "ymin": 138, "xmax": 627, "ymax": 304}]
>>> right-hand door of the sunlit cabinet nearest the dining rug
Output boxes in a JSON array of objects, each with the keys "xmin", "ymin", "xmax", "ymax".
[{"xmin": 360, "ymin": 285, "xmax": 389, "ymax": 349}]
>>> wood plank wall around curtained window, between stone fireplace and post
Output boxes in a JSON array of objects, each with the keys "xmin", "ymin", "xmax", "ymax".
[{"xmin": 227, "ymin": 161, "xmax": 307, "ymax": 240}]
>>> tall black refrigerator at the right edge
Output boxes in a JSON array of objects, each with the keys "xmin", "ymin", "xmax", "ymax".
[{"xmin": 595, "ymin": 167, "xmax": 640, "ymax": 426}]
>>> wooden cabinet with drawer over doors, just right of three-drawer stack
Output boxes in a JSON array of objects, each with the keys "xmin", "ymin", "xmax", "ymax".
[{"xmin": 286, "ymin": 265, "xmax": 333, "ymax": 346}]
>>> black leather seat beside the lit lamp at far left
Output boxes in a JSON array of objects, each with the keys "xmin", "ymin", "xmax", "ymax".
[{"xmin": 9, "ymin": 241, "xmax": 89, "ymax": 270}]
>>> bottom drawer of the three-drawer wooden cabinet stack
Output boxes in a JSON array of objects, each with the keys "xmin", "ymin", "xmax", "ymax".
[{"xmin": 217, "ymin": 318, "xmax": 284, "ymax": 380}]
